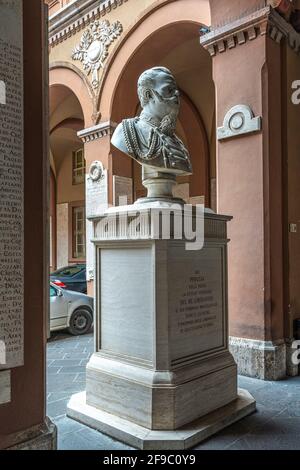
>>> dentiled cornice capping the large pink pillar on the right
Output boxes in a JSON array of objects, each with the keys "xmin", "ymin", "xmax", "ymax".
[{"xmin": 200, "ymin": 6, "xmax": 300, "ymax": 56}]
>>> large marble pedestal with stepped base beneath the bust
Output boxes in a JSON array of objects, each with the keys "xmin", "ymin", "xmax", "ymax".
[{"xmin": 68, "ymin": 204, "xmax": 255, "ymax": 449}]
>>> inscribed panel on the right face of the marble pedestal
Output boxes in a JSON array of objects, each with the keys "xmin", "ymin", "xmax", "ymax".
[{"xmin": 169, "ymin": 246, "xmax": 225, "ymax": 360}]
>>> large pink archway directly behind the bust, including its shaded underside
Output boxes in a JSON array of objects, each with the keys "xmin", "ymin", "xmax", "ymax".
[{"xmin": 98, "ymin": 0, "xmax": 214, "ymax": 205}]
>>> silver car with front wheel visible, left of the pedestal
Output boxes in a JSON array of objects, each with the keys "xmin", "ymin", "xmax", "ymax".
[{"xmin": 50, "ymin": 283, "xmax": 94, "ymax": 335}]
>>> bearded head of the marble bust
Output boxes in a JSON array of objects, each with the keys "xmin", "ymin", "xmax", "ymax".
[{"xmin": 138, "ymin": 67, "xmax": 180, "ymax": 124}]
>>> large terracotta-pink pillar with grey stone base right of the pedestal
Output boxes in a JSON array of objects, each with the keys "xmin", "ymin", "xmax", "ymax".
[{"xmin": 201, "ymin": 1, "xmax": 297, "ymax": 380}]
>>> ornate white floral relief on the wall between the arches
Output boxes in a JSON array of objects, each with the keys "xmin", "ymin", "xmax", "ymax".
[{"xmin": 71, "ymin": 20, "xmax": 123, "ymax": 88}]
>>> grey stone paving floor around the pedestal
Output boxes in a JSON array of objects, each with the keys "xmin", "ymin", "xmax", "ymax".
[{"xmin": 47, "ymin": 333, "xmax": 300, "ymax": 450}]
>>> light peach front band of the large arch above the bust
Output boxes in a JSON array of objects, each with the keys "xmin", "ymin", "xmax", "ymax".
[{"xmin": 97, "ymin": 0, "xmax": 211, "ymax": 121}]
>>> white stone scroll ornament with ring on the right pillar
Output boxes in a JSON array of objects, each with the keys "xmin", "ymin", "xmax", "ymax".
[{"xmin": 217, "ymin": 104, "xmax": 262, "ymax": 140}]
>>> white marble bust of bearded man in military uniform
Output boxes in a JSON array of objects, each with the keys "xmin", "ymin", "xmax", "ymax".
[{"xmin": 111, "ymin": 67, "xmax": 192, "ymax": 175}]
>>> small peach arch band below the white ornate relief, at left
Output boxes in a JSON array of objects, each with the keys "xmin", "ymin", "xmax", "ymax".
[{"xmin": 49, "ymin": 62, "xmax": 95, "ymax": 127}]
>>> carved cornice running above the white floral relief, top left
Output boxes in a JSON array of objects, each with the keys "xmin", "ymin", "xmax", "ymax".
[{"xmin": 49, "ymin": 0, "xmax": 128, "ymax": 47}]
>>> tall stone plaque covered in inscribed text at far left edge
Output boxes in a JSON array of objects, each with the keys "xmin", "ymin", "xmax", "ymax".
[{"xmin": 0, "ymin": 0, "xmax": 24, "ymax": 369}]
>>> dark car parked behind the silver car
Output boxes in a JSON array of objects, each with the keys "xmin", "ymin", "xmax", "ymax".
[{"xmin": 50, "ymin": 264, "xmax": 87, "ymax": 294}]
